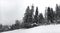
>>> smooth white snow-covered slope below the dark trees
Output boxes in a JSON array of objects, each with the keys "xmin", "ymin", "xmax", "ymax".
[{"xmin": 2, "ymin": 24, "xmax": 60, "ymax": 33}]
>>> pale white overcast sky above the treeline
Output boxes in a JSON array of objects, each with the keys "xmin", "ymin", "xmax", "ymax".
[{"xmin": 0, "ymin": 0, "xmax": 60, "ymax": 24}]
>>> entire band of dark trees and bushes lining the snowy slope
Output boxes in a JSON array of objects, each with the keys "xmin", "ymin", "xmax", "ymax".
[{"xmin": 0, "ymin": 4, "xmax": 60, "ymax": 32}]
